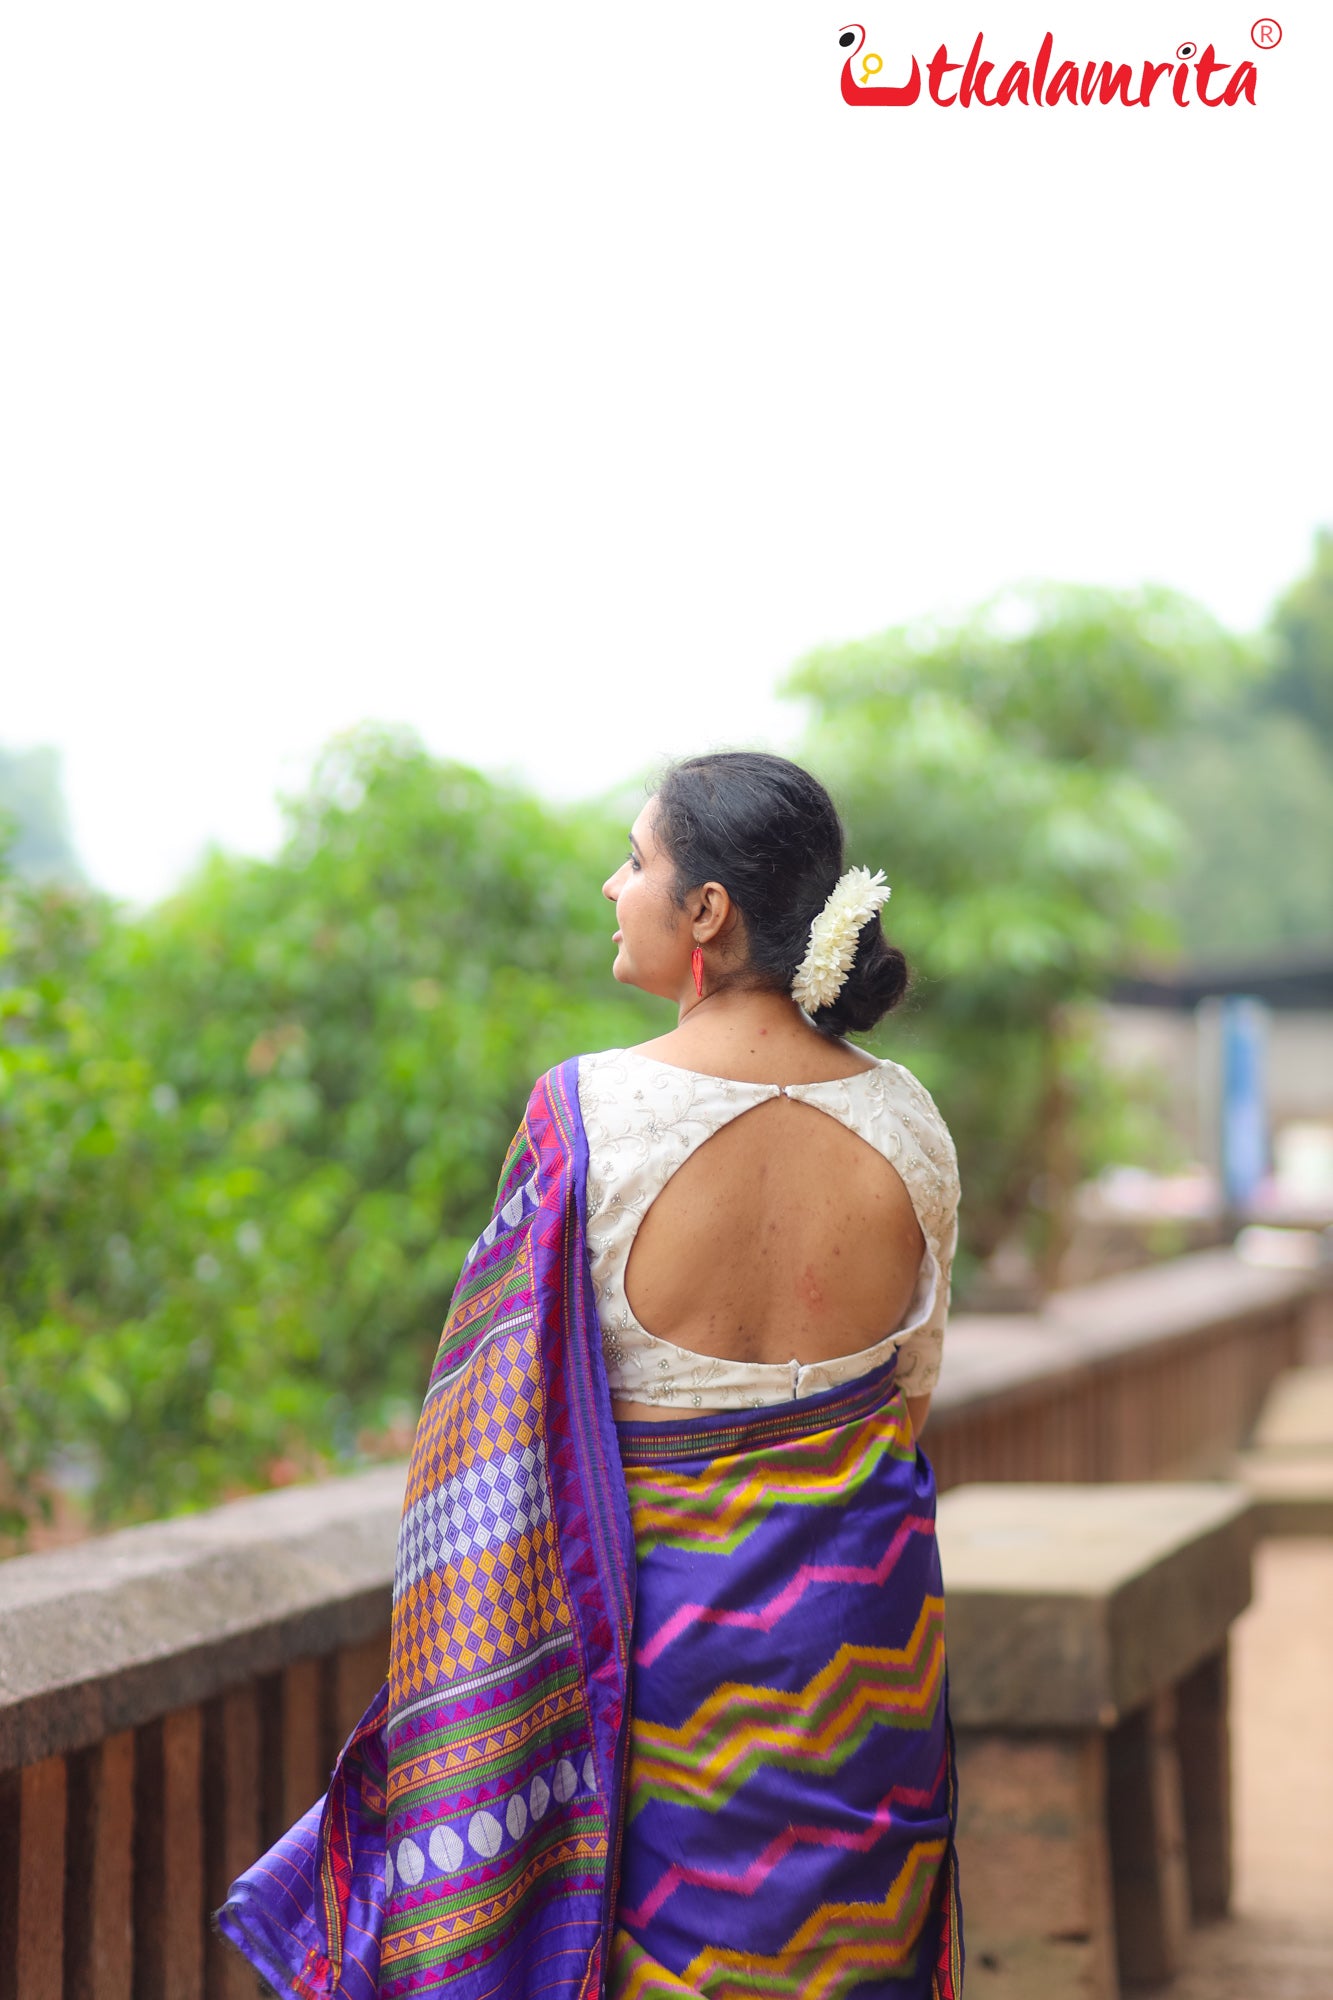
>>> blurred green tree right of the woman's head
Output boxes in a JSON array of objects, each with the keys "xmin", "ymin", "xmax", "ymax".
[{"xmin": 789, "ymin": 588, "xmax": 1251, "ymax": 1270}]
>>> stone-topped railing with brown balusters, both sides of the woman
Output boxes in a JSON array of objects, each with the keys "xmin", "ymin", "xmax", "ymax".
[{"xmin": 0, "ymin": 1252, "xmax": 1321, "ymax": 2000}]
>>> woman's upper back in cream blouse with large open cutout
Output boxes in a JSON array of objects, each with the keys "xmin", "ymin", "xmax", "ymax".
[{"xmin": 580, "ymin": 1006, "xmax": 957, "ymax": 1416}]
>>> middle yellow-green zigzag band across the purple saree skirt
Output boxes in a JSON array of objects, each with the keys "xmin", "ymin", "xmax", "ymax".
[{"xmin": 628, "ymin": 1598, "xmax": 945, "ymax": 1816}]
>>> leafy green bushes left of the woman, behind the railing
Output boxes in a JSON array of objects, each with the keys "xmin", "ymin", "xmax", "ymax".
[{"xmin": 0, "ymin": 732, "xmax": 660, "ymax": 1518}]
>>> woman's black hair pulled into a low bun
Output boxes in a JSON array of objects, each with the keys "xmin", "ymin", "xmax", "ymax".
[{"xmin": 654, "ymin": 750, "xmax": 907, "ymax": 1036}]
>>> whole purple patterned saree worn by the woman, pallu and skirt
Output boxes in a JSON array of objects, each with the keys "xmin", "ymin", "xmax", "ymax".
[{"xmin": 218, "ymin": 1060, "xmax": 963, "ymax": 2000}]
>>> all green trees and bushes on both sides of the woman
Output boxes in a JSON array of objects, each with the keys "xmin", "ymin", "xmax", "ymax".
[{"xmin": 0, "ymin": 534, "xmax": 1333, "ymax": 1528}]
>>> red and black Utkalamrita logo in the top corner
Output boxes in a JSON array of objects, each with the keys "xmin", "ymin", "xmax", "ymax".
[{"xmin": 839, "ymin": 16, "xmax": 1283, "ymax": 110}]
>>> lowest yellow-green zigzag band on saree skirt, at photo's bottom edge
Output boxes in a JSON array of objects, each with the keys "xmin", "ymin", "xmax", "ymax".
[{"xmin": 685, "ymin": 1840, "xmax": 945, "ymax": 2000}]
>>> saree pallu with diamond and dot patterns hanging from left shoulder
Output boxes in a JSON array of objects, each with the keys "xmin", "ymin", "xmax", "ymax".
[{"xmin": 216, "ymin": 1060, "xmax": 634, "ymax": 2000}]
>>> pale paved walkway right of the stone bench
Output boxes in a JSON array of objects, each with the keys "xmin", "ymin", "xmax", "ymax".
[{"xmin": 1163, "ymin": 1540, "xmax": 1333, "ymax": 2000}]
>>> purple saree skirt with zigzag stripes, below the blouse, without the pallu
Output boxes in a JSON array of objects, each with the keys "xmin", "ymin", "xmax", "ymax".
[{"xmin": 610, "ymin": 1362, "xmax": 963, "ymax": 2000}]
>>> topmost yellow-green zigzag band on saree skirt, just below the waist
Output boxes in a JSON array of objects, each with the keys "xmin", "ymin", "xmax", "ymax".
[{"xmin": 624, "ymin": 1396, "xmax": 917, "ymax": 1560}]
